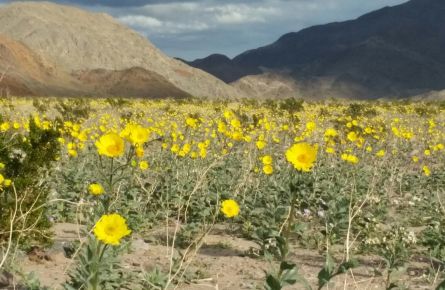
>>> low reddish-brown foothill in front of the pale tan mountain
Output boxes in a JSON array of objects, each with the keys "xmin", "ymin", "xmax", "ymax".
[{"xmin": 0, "ymin": 35, "xmax": 189, "ymax": 98}]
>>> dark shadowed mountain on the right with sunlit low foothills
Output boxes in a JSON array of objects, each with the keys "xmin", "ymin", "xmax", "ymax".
[{"xmin": 188, "ymin": 0, "xmax": 445, "ymax": 98}]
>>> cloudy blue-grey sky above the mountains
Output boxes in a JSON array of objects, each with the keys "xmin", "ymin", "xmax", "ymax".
[{"xmin": 0, "ymin": 0, "xmax": 407, "ymax": 60}]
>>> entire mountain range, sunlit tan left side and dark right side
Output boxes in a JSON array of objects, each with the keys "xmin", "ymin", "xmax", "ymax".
[{"xmin": 0, "ymin": 0, "xmax": 445, "ymax": 99}]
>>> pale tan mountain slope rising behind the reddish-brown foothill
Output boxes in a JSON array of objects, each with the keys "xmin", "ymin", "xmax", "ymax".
[{"xmin": 0, "ymin": 2, "xmax": 241, "ymax": 97}]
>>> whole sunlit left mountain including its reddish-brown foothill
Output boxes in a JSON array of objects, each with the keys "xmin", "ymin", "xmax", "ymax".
[{"xmin": 0, "ymin": 2, "xmax": 242, "ymax": 97}]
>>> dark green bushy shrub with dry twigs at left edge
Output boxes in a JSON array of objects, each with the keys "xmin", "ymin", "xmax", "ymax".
[{"xmin": 0, "ymin": 119, "xmax": 59, "ymax": 246}]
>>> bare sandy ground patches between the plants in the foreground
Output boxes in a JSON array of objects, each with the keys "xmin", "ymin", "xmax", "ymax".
[{"xmin": 11, "ymin": 224, "xmax": 433, "ymax": 290}]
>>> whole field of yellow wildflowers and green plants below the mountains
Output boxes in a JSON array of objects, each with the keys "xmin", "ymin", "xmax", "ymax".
[{"xmin": 0, "ymin": 98, "xmax": 445, "ymax": 290}]
